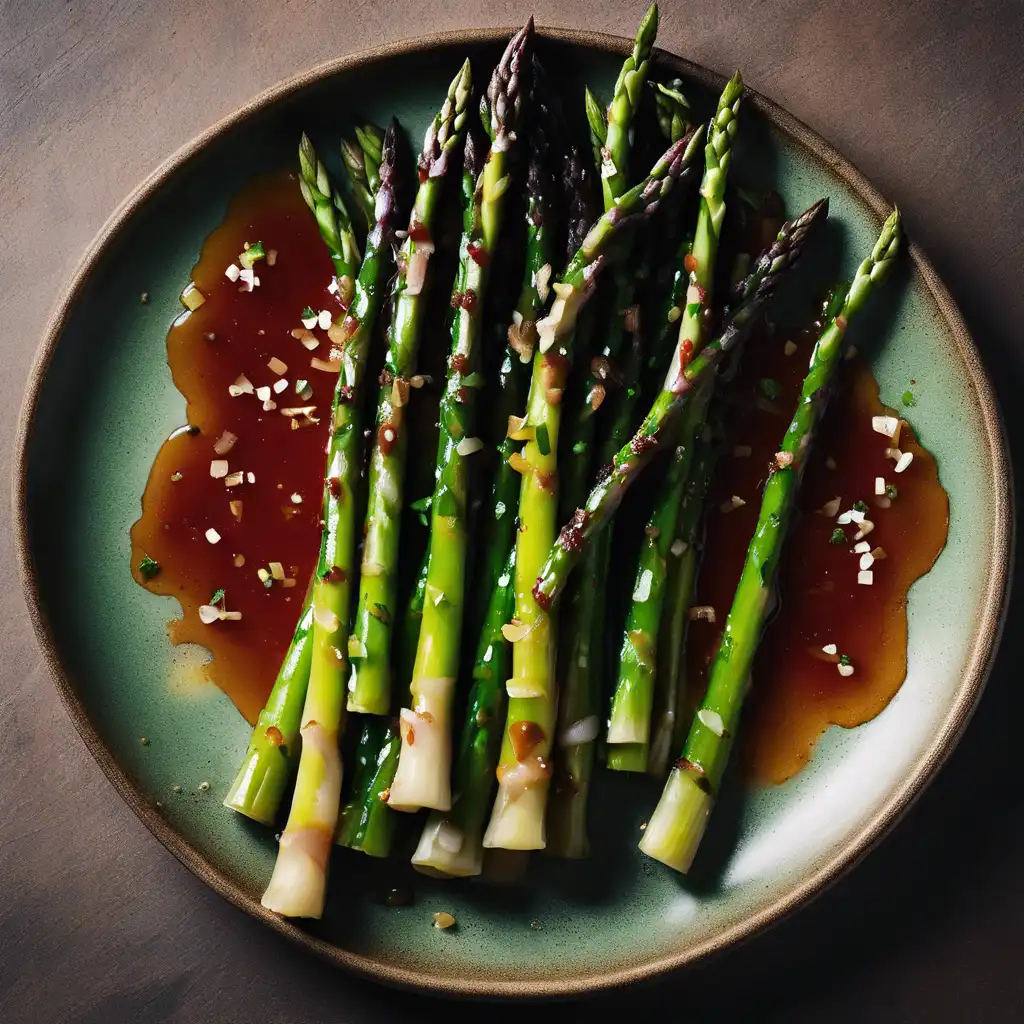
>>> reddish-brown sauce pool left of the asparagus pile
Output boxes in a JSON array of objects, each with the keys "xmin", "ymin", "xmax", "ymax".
[{"xmin": 131, "ymin": 173, "xmax": 339, "ymax": 722}]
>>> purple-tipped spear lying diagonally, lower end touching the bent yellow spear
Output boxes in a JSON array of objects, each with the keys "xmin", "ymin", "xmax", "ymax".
[{"xmin": 532, "ymin": 200, "xmax": 828, "ymax": 610}]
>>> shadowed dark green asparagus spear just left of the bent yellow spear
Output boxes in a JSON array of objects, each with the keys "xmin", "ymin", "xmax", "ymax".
[{"xmin": 413, "ymin": 72, "xmax": 565, "ymax": 877}]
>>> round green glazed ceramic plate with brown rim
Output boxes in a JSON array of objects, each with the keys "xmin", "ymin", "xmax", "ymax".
[{"xmin": 14, "ymin": 30, "xmax": 1013, "ymax": 996}]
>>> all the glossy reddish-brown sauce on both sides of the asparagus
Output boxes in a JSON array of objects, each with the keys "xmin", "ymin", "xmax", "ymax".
[{"xmin": 131, "ymin": 174, "xmax": 948, "ymax": 781}]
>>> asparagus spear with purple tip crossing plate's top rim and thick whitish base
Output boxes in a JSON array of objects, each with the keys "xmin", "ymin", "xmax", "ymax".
[{"xmin": 388, "ymin": 19, "xmax": 534, "ymax": 811}]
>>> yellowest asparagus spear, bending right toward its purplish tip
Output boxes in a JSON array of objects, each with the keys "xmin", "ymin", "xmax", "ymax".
[{"xmin": 483, "ymin": 132, "xmax": 697, "ymax": 850}]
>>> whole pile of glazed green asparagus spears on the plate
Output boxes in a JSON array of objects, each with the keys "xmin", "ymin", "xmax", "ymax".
[{"xmin": 218, "ymin": 5, "xmax": 913, "ymax": 918}]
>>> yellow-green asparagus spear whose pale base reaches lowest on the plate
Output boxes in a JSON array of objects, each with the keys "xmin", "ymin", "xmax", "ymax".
[{"xmin": 262, "ymin": 121, "xmax": 397, "ymax": 918}]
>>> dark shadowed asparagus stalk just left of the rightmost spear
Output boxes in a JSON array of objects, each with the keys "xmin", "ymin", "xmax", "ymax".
[{"xmin": 647, "ymin": 425, "xmax": 717, "ymax": 778}]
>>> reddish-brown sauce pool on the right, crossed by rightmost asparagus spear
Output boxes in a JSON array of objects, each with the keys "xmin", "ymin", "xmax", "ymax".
[{"xmin": 688, "ymin": 323, "xmax": 949, "ymax": 782}]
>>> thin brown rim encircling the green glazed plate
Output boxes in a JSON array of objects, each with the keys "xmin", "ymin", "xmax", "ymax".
[{"xmin": 11, "ymin": 27, "xmax": 1016, "ymax": 998}]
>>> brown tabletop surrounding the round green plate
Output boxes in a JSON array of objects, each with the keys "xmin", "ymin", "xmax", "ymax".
[{"xmin": 0, "ymin": 0, "xmax": 1024, "ymax": 1024}]
